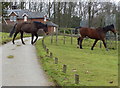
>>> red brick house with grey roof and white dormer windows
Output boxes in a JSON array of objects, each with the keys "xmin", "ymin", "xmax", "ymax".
[{"xmin": 5, "ymin": 6, "xmax": 58, "ymax": 32}]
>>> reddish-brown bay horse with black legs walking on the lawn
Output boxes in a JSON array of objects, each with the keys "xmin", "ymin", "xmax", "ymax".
[{"xmin": 77, "ymin": 24, "xmax": 116, "ymax": 50}]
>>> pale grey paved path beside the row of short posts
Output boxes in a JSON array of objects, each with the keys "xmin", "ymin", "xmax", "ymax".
[{"xmin": 2, "ymin": 38, "xmax": 51, "ymax": 86}]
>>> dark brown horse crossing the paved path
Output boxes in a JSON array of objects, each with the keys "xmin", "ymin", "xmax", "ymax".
[{"xmin": 9, "ymin": 21, "xmax": 48, "ymax": 44}]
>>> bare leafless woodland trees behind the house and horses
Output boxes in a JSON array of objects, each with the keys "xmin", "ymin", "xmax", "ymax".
[{"xmin": 2, "ymin": 0, "xmax": 119, "ymax": 27}]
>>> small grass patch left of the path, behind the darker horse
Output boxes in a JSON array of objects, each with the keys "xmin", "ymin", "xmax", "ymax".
[{"xmin": 0, "ymin": 32, "xmax": 30, "ymax": 45}]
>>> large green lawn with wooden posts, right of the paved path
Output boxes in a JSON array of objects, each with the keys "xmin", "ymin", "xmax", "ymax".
[{"xmin": 36, "ymin": 36, "xmax": 118, "ymax": 86}]
